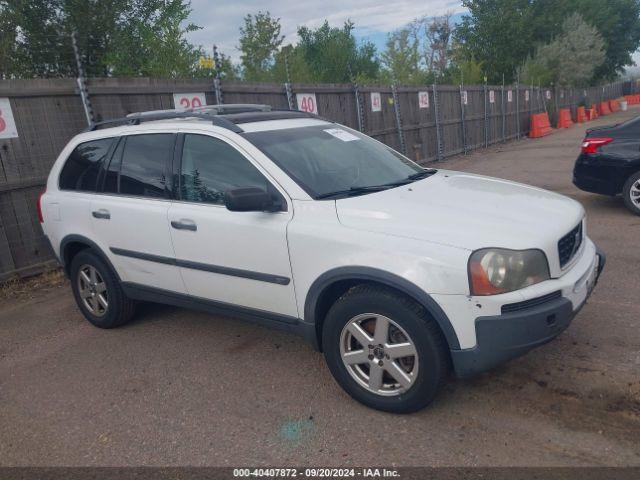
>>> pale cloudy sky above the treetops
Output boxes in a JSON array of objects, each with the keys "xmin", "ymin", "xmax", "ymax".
[{"xmin": 189, "ymin": 0, "xmax": 465, "ymax": 61}]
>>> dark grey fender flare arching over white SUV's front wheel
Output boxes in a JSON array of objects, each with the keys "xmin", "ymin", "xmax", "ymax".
[{"xmin": 304, "ymin": 267, "xmax": 460, "ymax": 350}]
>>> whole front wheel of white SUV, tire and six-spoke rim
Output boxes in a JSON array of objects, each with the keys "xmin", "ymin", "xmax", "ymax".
[{"xmin": 322, "ymin": 284, "xmax": 449, "ymax": 413}]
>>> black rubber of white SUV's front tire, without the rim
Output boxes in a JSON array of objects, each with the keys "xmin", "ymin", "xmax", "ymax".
[{"xmin": 322, "ymin": 284, "xmax": 450, "ymax": 413}]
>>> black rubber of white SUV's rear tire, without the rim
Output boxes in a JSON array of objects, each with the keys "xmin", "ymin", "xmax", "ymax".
[{"xmin": 69, "ymin": 249, "xmax": 135, "ymax": 328}]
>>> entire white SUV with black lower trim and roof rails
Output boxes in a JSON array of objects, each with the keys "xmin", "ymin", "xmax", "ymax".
[{"xmin": 38, "ymin": 105, "xmax": 605, "ymax": 412}]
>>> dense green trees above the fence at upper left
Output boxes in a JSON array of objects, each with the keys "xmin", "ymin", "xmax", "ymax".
[{"xmin": 0, "ymin": 0, "xmax": 200, "ymax": 77}]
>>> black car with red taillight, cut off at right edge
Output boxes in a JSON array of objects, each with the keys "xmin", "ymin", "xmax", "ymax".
[{"xmin": 573, "ymin": 117, "xmax": 640, "ymax": 215}]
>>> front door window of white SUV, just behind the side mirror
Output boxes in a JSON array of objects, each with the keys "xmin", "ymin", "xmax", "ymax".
[{"xmin": 180, "ymin": 134, "xmax": 268, "ymax": 204}]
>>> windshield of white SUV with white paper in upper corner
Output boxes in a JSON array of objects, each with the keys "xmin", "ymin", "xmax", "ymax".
[{"xmin": 244, "ymin": 123, "xmax": 424, "ymax": 199}]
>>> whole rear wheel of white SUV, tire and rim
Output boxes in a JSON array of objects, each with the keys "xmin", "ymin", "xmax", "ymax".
[{"xmin": 70, "ymin": 250, "xmax": 135, "ymax": 328}]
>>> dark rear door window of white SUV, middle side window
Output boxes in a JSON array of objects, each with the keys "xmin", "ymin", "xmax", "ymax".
[{"xmin": 120, "ymin": 133, "xmax": 175, "ymax": 197}]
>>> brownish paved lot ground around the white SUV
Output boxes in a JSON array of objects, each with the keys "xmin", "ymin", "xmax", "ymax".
[{"xmin": 0, "ymin": 109, "xmax": 640, "ymax": 466}]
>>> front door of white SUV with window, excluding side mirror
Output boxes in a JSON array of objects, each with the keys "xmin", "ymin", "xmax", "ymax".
[{"xmin": 169, "ymin": 133, "xmax": 298, "ymax": 318}]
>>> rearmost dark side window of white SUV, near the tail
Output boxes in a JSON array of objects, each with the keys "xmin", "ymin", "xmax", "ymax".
[{"xmin": 60, "ymin": 138, "xmax": 113, "ymax": 192}]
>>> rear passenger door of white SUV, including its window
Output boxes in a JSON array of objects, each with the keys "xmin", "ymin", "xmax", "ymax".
[{"xmin": 91, "ymin": 133, "xmax": 185, "ymax": 293}]
